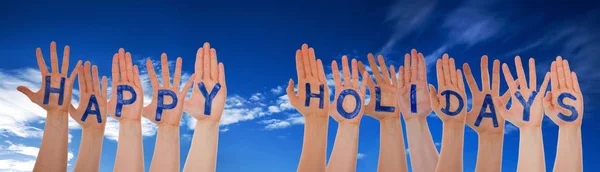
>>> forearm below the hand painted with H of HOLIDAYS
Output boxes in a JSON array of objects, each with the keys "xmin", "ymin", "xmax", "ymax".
[{"xmin": 297, "ymin": 115, "xmax": 329, "ymax": 172}]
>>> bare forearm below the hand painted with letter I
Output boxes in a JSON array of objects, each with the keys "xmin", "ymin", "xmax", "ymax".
[{"xmin": 406, "ymin": 117, "xmax": 438, "ymax": 172}]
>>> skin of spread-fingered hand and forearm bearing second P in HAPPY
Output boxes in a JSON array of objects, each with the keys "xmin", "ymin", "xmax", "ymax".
[{"xmin": 142, "ymin": 53, "xmax": 194, "ymax": 171}]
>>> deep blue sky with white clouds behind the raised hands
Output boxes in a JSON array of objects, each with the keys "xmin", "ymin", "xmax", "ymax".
[{"xmin": 0, "ymin": 0, "xmax": 600, "ymax": 172}]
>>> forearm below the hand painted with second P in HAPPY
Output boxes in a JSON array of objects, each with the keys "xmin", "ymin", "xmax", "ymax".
[{"xmin": 150, "ymin": 125, "xmax": 180, "ymax": 171}]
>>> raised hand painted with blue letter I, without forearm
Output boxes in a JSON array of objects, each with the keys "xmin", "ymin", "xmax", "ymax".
[{"xmin": 397, "ymin": 49, "xmax": 431, "ymax": 120}]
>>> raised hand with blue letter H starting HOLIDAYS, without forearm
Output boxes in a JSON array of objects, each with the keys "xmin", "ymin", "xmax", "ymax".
[{"xmin": 286, "ymin": 44, "xmax": 329, "ymax": 118}]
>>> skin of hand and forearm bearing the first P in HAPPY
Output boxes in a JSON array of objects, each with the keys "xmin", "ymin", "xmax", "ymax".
[{"xmin": 108, "ymin": 48, "xmax": 144, "ymax": 172}]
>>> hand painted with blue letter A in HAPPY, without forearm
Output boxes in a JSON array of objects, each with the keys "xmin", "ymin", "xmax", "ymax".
[{"xmin": 69, "ymin": 61, "xmax": 108, "ymax": 131}]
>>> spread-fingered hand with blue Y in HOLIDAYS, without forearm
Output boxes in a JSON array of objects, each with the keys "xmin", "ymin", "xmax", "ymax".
[{"xmin": 494, "ymin": 56, "xmax": 550, "ymax": 128}]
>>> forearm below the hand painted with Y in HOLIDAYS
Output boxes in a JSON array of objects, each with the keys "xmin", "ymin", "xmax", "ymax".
[{"xmin": 517, "ymin": 126, "xmax": 546, "ymax": 172}]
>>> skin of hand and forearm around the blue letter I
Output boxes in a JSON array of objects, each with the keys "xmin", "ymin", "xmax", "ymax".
[{"xmin": 397, "ymin": 49, "xmax": 438, "ymax": 172}]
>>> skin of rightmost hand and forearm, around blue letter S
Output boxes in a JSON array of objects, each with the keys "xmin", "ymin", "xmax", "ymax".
[{"xmin": 543, "ymin": 56, "xmax": 584, "ymax": 172}]
